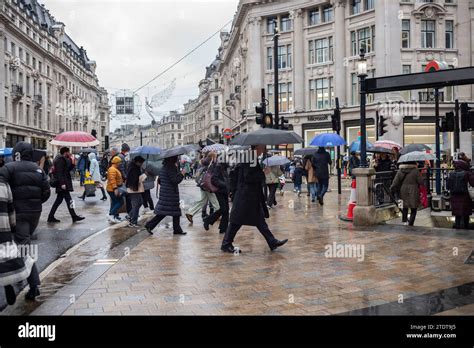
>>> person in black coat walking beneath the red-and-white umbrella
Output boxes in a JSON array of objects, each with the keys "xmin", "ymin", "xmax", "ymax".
[{"xmin": 48, "ymin": 147, "xmax": 85, "ymax": 223}]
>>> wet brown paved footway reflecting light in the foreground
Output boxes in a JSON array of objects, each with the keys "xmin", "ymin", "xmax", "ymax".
[{"xmin": 19, "ymin": 180, "xmax": 474, "ymax": 315}]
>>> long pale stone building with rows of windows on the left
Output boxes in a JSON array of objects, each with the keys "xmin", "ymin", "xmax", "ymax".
[{"xmin": 0, "ymin": 0, "xmax": 110, "ymax": 150}]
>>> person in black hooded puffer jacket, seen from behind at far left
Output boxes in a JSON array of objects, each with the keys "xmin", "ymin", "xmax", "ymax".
[{"xmin": 0, "ymin": 141, "xmax": 51, "ymax": 300}]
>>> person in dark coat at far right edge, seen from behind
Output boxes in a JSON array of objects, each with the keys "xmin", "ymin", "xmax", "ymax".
[{"xmin": 446, "ymin": 160, "xmax": 474, "ymax": 229}]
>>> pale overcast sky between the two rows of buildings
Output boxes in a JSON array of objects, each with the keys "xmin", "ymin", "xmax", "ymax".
[{"xmin": 41, "ymin": 0, "xmax": 238, "ymax": 131}]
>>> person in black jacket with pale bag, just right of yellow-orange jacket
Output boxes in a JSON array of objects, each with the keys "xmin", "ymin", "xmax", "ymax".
[{"xmin": 126, "ymin": 156, "xmax": 146, "ymax": 227}]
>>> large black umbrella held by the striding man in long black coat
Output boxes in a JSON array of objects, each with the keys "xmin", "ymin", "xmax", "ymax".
[{"xmin": 231, "ymin": 128, "xmax": 303, "ymax": 145}]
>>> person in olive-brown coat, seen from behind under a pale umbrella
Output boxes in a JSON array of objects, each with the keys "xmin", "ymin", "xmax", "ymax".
[{"xmin": 390, "ymin": 162, "xmax": 423, "ymax": 226}]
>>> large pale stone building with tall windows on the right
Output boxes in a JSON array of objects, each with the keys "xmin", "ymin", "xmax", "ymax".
[{"xmin": 185, "ymin": 0, "xmax": 474, "ymax": 154}]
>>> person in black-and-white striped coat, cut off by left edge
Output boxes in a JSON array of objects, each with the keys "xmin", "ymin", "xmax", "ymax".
[{"xmin": 0, "ymin": 177, "xmax": 34, "ymax": 305}]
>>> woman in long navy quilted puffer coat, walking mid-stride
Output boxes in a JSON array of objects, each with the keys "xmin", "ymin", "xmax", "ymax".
[{"xmin": 145, "ymin": 156, "xmax": 186, "ymax": 235}]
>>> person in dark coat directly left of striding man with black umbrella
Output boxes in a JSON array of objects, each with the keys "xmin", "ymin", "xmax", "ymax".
[{"xmin": 203, "ymin": 163, "xmax": 229, "ymax": 233}]
